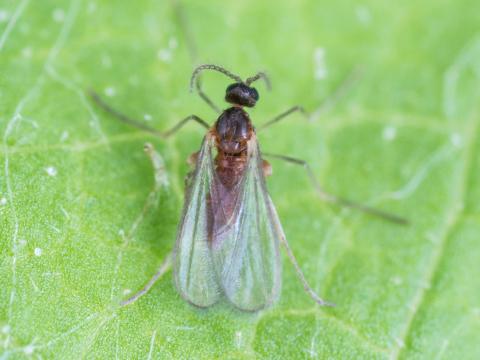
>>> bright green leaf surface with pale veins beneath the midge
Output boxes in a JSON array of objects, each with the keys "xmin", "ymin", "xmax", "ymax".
[{"xmin": 0, "ymin": 0, "xmax": 480, "ymax": 359}]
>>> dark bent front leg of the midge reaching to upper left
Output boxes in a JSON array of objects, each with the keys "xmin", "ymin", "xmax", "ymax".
[{"xmin": 89, "ymin": 90, "xmax": 210, "ymax": 138}]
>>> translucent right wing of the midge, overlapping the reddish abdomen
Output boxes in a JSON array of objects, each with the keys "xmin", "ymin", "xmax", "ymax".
[{"xmin": 211, "ymin": 136, "xmax": 283, "ymax": 311}]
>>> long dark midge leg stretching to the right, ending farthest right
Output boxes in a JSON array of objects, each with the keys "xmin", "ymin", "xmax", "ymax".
[{"xmin": 263, "ymin": 153, "xmax": 409, "ymax": 225}]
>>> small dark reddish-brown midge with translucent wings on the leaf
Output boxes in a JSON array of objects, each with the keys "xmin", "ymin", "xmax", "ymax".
[{"xmin": 92, "ymin": 64, "xmax": 405, "ymax": 311}]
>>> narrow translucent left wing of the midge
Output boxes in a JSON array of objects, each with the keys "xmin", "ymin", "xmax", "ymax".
[{"xmin": 173, "ymin": 135, "xmax": 221, "ymax": 307}]
